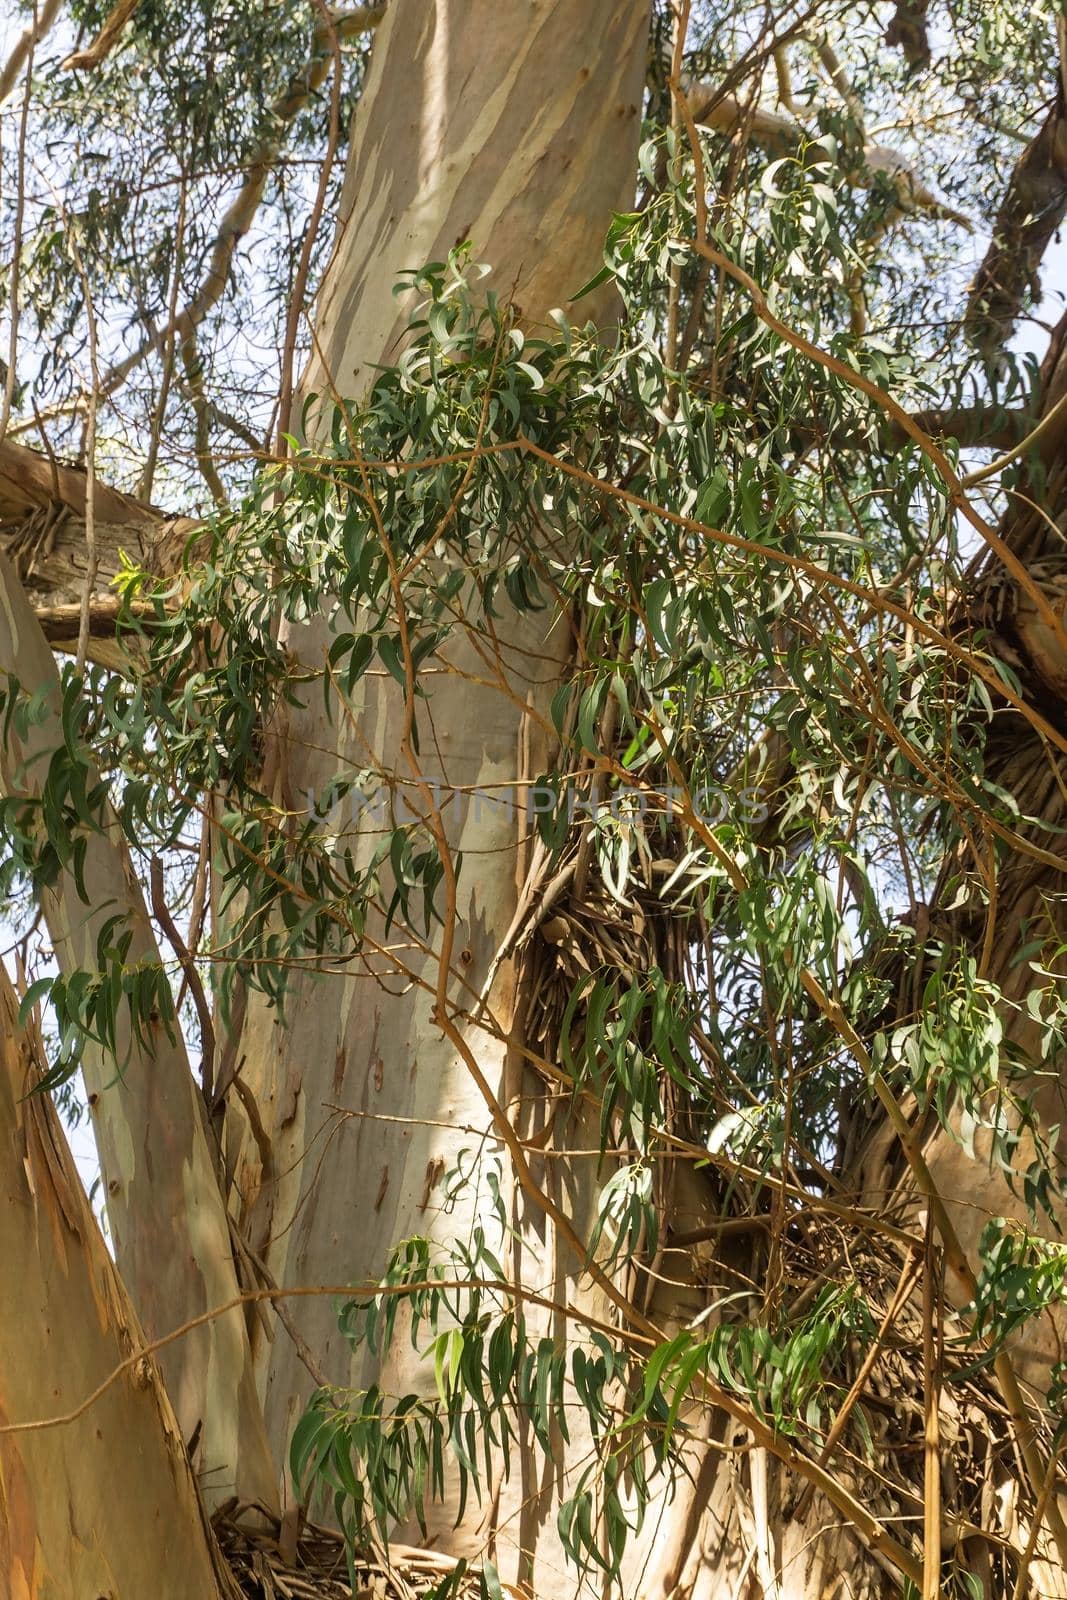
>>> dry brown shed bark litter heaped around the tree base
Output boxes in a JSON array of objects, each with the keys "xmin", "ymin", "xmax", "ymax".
[{"xmin": 214, "ymin": 1174, "xmax": 1059, "ymax": 1600}]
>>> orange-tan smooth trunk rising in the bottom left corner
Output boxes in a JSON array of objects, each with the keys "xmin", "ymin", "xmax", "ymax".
[{"xmin": 0, "ymin": 966, "xmax": 232, "ymax": 1600}]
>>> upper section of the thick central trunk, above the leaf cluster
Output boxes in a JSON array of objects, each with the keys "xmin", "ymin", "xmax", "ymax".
[{"xmin": 304, "ymin": 0, "xmax": 648, "ymax": 395}]
